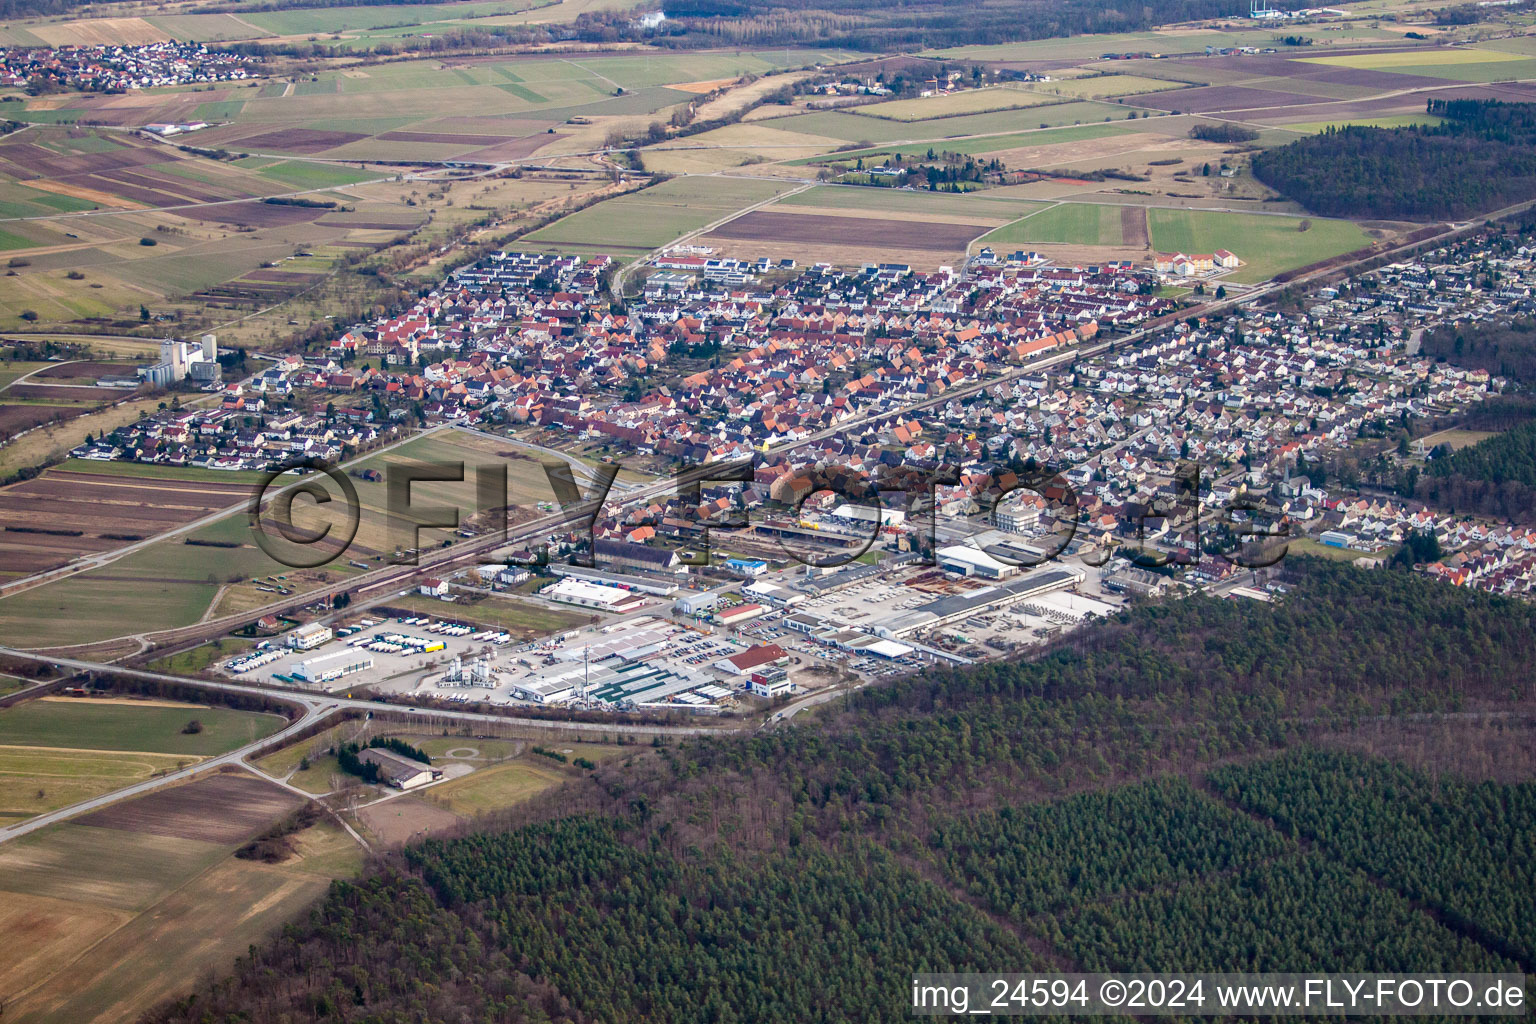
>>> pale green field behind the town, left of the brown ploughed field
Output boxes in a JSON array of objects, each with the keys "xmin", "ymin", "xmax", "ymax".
[{"xmin": 525, "ymin": 178, "xmax": 790, "ymax": 256}]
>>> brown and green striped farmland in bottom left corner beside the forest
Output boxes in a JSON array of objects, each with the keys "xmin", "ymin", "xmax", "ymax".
[{"xmin": 0, "ymin": 775, "xmax": 361, "ymax": 1024}]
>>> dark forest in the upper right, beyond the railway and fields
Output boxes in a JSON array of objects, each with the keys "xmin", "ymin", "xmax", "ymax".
[{"xmin": 1253, "ymin": 100, "xmax": 1536, "ymax": 220}]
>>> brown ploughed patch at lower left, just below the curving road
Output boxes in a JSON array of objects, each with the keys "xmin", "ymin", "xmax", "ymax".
[{"xmin": 75, "ymin": 774, "xmax": 301, "ymax": 843}]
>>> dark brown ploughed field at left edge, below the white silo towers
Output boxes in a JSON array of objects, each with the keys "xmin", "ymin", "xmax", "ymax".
[{"xmin": 0, "ymin": 469, "xmax": 250, "ymax": 573}]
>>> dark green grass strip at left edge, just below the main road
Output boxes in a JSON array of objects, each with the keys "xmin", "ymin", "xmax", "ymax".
[{"xmin": 0, "ymin": 699, "xmax": 283, "ymax": 757}]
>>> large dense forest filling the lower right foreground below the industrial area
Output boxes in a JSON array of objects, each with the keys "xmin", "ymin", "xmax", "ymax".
[{"xmin": 146, "ymin": 557, "xmax": 1536, "ymax": 1024}]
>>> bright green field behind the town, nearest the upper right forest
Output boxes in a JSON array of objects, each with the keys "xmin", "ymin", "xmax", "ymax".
[{"xmin": 1147, "ymin": 210, "xmax": 1372, "ymax": 282}]
